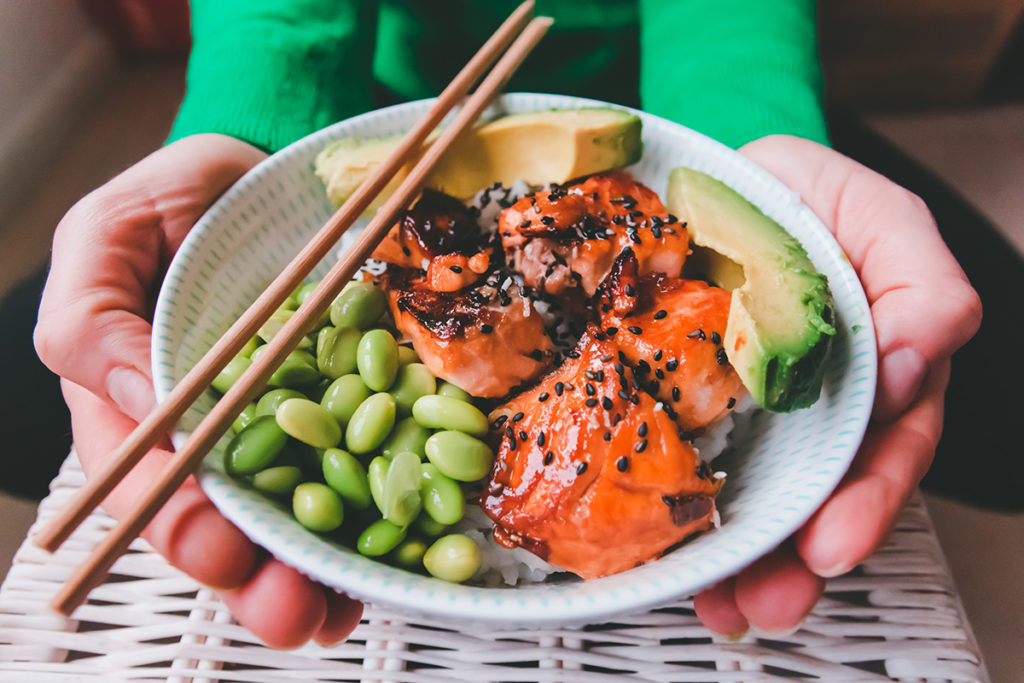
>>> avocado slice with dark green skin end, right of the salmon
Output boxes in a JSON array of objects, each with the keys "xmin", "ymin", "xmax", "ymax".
[{"xmin": 666, "ymin": 168, "xmax": 836, "ymax": 413}]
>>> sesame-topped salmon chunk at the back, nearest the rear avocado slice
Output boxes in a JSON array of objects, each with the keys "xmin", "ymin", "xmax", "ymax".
[{"xmin": 498, "ymin": 172, "xmax": 689, "ymax": 295}]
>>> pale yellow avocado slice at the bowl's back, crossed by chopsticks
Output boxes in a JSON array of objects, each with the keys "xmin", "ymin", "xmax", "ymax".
[{"xmin": 314, "ymin": 108, "xmax": 643, "ymax": 210}]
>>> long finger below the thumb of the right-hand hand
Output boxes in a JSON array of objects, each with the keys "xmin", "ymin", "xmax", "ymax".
[{"xmin": 797, "ymin": 360, "xmax": 949, "ymax": 577}]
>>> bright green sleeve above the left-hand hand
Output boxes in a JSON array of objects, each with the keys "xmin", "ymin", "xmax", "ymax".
[{"xmin": 169, "ymin": 0, "xmax": 377, "ymax": 152}]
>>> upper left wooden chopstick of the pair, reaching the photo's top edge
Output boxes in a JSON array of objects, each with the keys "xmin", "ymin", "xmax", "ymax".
[{"xmin": 33, "ymin": 0, "xmax": 534, "ymax": 552}]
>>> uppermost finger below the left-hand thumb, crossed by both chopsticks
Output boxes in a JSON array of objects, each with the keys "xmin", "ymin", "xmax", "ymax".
[{"xmin": 63, "ymin": 381, "xmax": 257, "ymax": 588}]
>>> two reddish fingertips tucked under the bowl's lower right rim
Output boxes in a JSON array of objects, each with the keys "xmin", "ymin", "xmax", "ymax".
[{"xmin": 693, "ymin": 544, "xmax": 825, "ymax": 638}]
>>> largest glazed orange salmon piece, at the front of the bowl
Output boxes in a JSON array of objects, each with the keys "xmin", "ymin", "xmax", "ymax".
[{"xmin": 480, "ymin": 326, "xmax": 721, "ymax": 579}]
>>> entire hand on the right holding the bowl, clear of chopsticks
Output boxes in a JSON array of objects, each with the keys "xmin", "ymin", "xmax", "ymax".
[{"xmin": 694, "ymin": 135, "xmax": 981, "ymax": 636}]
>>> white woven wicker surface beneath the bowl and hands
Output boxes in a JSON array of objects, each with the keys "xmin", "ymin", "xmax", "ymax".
[{"xmin": 0, "ymin": 458, "xmax": 987, "ymax": 683}]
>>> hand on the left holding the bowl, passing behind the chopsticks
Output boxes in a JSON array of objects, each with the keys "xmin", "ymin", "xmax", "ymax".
[{"xmin": 36, "ymin": 135, "xmax": 362, "ymax": 647}]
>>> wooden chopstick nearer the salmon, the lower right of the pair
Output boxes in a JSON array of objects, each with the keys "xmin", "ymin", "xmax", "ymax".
[{"xmin": 50, "ymin": 17, "xmax": 552, "ymax": 614}]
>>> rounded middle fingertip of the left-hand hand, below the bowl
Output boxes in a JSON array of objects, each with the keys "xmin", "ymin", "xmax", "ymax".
[{"xmin": 220, "ymin": 559, "xmax": 328, "ymax": 649}]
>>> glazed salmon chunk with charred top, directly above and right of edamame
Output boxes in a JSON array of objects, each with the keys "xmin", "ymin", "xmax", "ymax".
[{"xmin": 383, "ymin": 267, "xmax": 553, "ymax": 397}]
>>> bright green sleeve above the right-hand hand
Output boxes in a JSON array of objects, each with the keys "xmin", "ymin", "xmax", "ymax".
[{"xmin": 639, "ymin": 0, "xmax": 828, "ymax": 146}]
